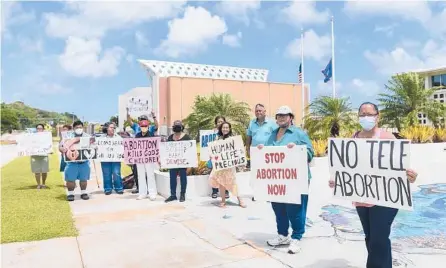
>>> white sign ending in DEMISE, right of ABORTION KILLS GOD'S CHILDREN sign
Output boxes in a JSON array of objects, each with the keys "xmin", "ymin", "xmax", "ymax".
[{"xmin": 160, "ymin": 140, "xmax": 198, "ymax": 169}]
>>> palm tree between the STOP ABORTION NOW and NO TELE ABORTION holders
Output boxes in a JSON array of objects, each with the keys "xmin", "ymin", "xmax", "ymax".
[{"xmin": 304, "ymin": 96, "xmax": 358, "ymax": 140}]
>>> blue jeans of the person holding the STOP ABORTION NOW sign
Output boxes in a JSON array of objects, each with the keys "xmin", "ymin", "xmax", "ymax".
[{"xmin": 271, "ymin": 195, "xmax": 308, "ymax": 240}]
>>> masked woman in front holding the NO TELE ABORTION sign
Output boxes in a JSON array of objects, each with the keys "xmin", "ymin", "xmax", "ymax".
[{"xmin": 329, "ymin": 102, "xmax": 417, "ymax": 268}]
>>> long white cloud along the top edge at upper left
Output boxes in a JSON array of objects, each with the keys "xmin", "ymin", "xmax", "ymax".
[{"xmin": 43, "ymin": 1, "xmax": 185, "ymax": 38}]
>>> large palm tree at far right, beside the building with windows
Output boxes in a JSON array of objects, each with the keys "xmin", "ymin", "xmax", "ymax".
[{"xmin": 378, "ymin": 73, "xmax": 446, "ymax": 131}]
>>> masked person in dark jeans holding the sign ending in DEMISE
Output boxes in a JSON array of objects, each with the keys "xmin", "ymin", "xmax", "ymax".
[{"xmin": 165, "ymin": 120, "xmax": 191, "ymax": 203}]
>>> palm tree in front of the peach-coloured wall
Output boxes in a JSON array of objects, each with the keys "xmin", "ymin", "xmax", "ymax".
[{"xmin": 184, "ymin": 94, "xmax": 251, "ymax": 139}]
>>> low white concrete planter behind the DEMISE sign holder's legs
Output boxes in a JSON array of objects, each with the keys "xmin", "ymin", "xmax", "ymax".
[{"xmin": 155, "ymin": 170, "xmax": 212, "ymax": 198}]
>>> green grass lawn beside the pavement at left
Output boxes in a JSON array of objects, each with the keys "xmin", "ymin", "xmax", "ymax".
[{"xmin": 1, "ymin": 153, "xmax": 77, "ymax": 243}]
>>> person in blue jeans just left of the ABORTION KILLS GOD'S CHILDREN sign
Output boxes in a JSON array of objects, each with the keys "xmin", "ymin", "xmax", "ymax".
[{"xmin": 101, "ymin": 122, "xmax": 124, "ymax": 195}]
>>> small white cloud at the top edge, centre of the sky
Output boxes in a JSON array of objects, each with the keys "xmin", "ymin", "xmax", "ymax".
[{"xmin": 216, "ymin": 0, "xmax": 261, "ymax": 26}]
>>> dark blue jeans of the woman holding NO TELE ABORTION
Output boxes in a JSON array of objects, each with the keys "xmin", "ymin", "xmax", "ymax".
[{"xmin": 356, "ymin": 206, "xmax": 398, "ymax": 268}]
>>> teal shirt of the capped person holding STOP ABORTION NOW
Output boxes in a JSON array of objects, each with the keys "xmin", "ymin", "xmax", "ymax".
[{"xmin": 264, "ymin": 126, "xmax": 314, "ymax": 179}]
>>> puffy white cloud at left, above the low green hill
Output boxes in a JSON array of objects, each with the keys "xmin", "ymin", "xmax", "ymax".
[{"xmin": 59, "ymin": 37, "xmax": 125, "ymax": 77}]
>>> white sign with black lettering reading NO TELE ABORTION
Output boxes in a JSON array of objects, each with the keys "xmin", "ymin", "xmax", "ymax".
[{"xmin": 328, "ymin": 139, "xmax": 413, "ymax": 210}]
